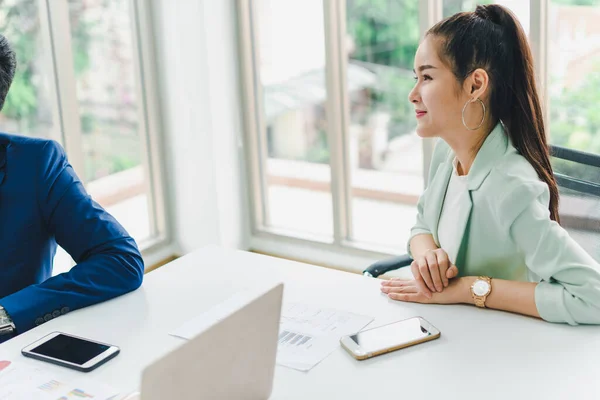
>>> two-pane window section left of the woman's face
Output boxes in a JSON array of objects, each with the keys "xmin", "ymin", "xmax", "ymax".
[{"xmin": 240, "ymin": 0, "xmax": 440, "ymax": 262}]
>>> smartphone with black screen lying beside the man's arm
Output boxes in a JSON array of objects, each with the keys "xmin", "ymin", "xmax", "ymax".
[{"xmin": 21, "ymin": 332, "xmax": 120, "ymax": 372}]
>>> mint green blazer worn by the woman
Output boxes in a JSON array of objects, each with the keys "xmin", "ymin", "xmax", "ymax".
[{"xmin": 408, "ymin": 124, "xmax": 600, "ymax": 325}]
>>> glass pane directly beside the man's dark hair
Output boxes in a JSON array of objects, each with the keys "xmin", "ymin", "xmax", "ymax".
[{"xmin": 0, "ymin": 0, "xmax": 58, "ymax": 139}]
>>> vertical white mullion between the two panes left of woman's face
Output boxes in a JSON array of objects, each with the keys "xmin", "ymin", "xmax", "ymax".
[{"xmin": 323, "ymin": 0, "xmax": 352, "ymax": 244}]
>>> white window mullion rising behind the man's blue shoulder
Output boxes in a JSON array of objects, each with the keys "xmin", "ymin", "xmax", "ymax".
[{"xmin": 41, "ymin": 0, "xmax": 85, "ymax": 182}]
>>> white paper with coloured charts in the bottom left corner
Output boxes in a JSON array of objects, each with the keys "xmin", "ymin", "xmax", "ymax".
[{"xmin": 0, "ymin": 361, "xmax": 120, "ymax": 400}]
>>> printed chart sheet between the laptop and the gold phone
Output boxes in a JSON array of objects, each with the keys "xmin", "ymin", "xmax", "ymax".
[{"xmin": 277, "ymin": 303, "xmax": 373, "ymax": 371}]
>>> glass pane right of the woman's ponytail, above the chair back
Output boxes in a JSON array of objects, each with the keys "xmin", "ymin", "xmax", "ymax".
[{"xmin": 548, "ymin": 0, "xmax": 600, "ymax": 153}]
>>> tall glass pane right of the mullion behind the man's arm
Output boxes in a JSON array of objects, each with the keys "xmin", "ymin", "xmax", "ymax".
[{"xmin": 69, "ymin": 0, "xmax": 152, "ymax": 242}]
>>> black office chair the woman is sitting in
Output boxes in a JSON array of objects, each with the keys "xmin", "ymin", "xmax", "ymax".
[{"xmin": 363, "ymin": 146, "xmax": 600, "ymax": 278}]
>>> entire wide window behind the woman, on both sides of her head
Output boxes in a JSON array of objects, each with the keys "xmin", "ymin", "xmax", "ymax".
[{"xmin": 239, "ymin": 0, "xmax": 600, "ymax": 269}]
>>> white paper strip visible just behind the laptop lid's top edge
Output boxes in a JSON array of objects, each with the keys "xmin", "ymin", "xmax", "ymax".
[{"xmin": 169, "ymin": 290, "xmax": 256, "ymax": 340}]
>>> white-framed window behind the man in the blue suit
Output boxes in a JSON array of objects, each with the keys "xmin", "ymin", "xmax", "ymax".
[{"xmin": 0, "ymin": 0, "xmax": 165, "ymax": 273}]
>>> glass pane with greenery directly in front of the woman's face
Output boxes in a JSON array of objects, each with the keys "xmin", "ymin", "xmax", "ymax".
[{"xmin": 346, "ymin": 0, "xmax": 423, "ymax": 249}]
